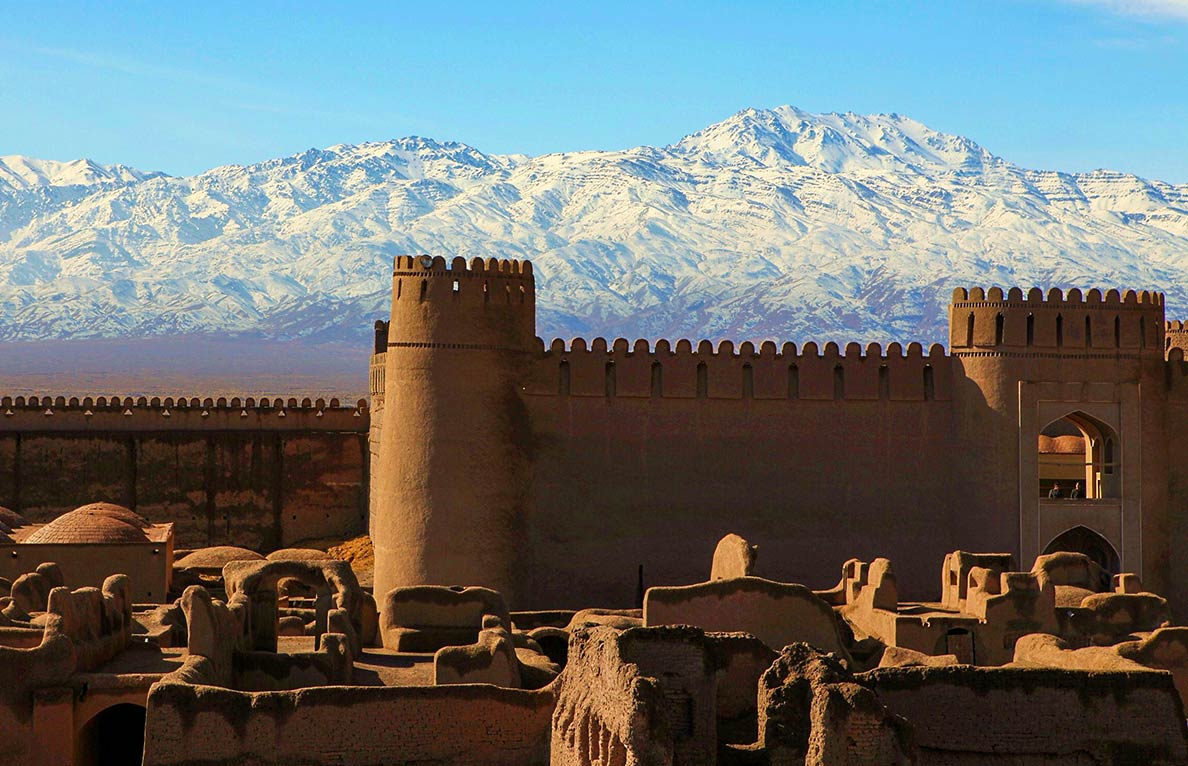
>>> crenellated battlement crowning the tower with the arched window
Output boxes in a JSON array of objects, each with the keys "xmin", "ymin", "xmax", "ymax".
[{"xmin": 949, "ymin": 287, "xmax": 1164, "ymax": 356}]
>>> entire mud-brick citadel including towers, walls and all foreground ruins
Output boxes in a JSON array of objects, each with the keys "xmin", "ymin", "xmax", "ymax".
[{"xmin": 0, "ymin": 257, "xmax": 1188, "ymax": 766}]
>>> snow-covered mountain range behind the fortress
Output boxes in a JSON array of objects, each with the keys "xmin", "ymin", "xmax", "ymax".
[{"xmin": 0, "ymin": 107, "xmax": 1188, "ymax": 343}]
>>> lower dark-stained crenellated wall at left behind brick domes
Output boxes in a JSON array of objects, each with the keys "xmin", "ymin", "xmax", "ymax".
[{"xmin": 0, "ymin": 397, "xmax": 368, "ymax": 551}]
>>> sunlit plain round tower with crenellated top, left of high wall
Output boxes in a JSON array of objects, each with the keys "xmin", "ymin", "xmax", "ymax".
[{"xmin": 369, "ymin": 255, "xmax": 536, "ymax": 608}]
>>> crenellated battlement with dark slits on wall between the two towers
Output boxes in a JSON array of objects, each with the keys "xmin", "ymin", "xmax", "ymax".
[{"xmin": 524, "ymin": 337, "xmax": 952, "ymax": 401}]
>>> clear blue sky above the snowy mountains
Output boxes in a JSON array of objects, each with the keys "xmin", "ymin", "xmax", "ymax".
[{"xmin": 0, "ymin": 0, "xmax": 1188, "ymax": 183}]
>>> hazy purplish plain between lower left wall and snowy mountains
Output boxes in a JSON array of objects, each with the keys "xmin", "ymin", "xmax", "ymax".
[{"xmin": 0, "ymin": 335, "xmax": 371, "ymax": 401}]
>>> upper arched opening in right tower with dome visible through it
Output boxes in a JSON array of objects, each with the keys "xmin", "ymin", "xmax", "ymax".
[{"xmin": 1037, "ymin": 412, "xmax": 1121, "ymax": 500}]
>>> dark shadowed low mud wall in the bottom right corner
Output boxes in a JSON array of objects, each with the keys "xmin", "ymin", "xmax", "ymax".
[{"xmin": 860, "ymin": 665, "xmax": 1188, "ymax": 766}]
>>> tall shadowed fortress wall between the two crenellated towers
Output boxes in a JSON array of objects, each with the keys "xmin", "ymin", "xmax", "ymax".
[{"xmin": 513, "ymin": 341, "xmax": 974, "ymax": 608}]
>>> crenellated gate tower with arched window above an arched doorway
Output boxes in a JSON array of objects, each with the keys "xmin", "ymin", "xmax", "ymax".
[{"xmin": 949, "ymin": 287, "xmax": 1168, "ymax": 590}]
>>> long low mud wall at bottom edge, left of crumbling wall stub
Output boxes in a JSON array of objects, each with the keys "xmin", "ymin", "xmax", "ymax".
[{"xmin": 144, "ymin": 683, "xmax": 556, "ymax": 766}]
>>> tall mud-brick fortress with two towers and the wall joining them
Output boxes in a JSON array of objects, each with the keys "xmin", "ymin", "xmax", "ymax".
[{"xmin": 369, "ymin": 257, "xmax": 1188, "ymax": 608}]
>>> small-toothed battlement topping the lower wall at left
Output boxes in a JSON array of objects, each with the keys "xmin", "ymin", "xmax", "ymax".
[{"xmin": 0, "ymin": 395, "xmax": 368, "ymax": 431}]
